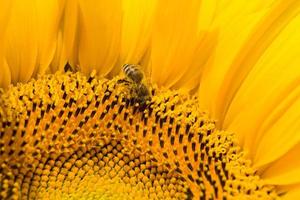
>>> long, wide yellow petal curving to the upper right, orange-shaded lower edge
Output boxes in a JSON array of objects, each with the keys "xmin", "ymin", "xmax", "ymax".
[{"xmin": 199, "ymin": 0, "xmax": 292, "ymax": 123}]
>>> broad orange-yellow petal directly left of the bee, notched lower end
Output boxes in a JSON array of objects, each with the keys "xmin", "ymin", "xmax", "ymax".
[{"xmin": 78, "ymin": 0, "xmax": 122, "ymax": 75}]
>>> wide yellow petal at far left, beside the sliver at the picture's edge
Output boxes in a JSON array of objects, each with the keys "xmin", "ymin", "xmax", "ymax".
[{"xmin": 5, "ymin": 0, "xmax": 38, "ymax": 83}]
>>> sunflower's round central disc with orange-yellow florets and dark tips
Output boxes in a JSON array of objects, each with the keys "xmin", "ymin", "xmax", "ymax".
[{"xmin": 0, "ymin": 72, "xmax": 277, "ymax": 199}]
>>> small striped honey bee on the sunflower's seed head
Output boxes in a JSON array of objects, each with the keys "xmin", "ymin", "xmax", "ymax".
[{"xmin": 122, "ymin": 64, "xmax": 151, "ymax": 107}]
